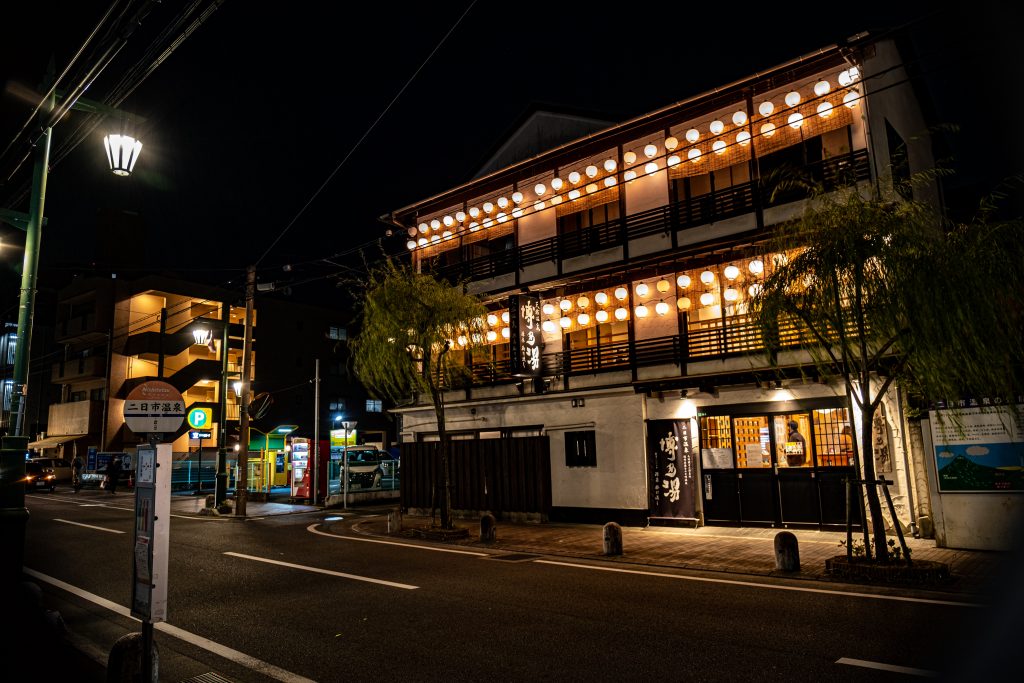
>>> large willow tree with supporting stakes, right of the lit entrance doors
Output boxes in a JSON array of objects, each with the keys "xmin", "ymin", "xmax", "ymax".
[{"xmin": 750, "ymin": 176, "xmax": 1024, "ymax": 561}]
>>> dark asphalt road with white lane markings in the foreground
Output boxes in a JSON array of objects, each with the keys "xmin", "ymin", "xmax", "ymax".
[{"xmin": 16, "ymin": 490, "xmax": 1016, "ymax": 681}]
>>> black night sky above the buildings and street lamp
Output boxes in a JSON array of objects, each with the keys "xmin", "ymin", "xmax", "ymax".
[{"xmin": 0, "ymin": 0, "xmax": 1022, "ymax": 307}]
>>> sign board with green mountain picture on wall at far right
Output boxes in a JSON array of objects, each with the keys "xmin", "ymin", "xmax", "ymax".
[{"xmin": 930, "ymin": 407, "xmax": 1024, "ymax": 493}]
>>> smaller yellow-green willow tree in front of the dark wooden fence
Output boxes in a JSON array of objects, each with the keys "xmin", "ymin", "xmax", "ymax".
[{"xmin": 351, "ymin": 260, "xmax": 485, "ymax": 528}]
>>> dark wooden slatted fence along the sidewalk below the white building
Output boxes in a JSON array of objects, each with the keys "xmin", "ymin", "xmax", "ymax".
[{"xmin": 401, "ymin": 436, "xmax": 551, "ymax": 519}]
